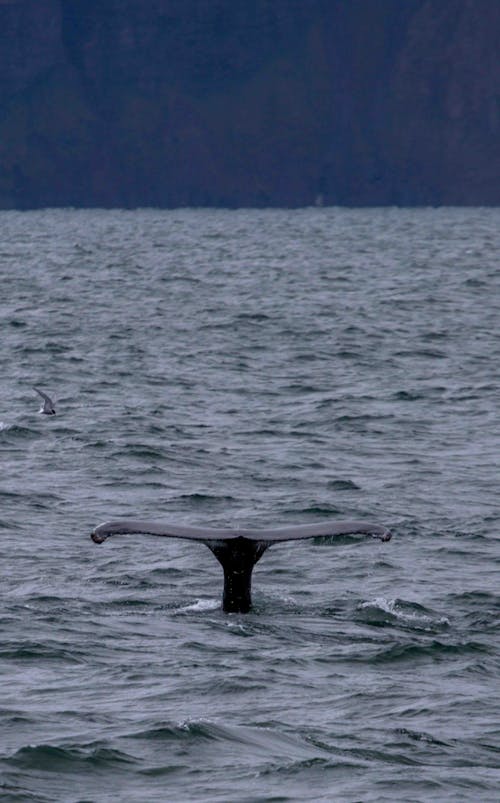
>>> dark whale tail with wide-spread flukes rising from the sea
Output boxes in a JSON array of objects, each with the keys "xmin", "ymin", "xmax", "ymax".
[{"xmin": 90, "ymin": 519, "xmax": 391, "ymax": 613}]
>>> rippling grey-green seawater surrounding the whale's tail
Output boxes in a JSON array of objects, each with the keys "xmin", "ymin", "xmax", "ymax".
[{"xmin": 0, "ymin": 209, "xmax": 500, "ymax": 803}]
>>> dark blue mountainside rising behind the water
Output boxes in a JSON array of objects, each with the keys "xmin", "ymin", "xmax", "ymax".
[{"xmin": 0, "ymin": 0, "xmax": 500, "ymax": 208}]
